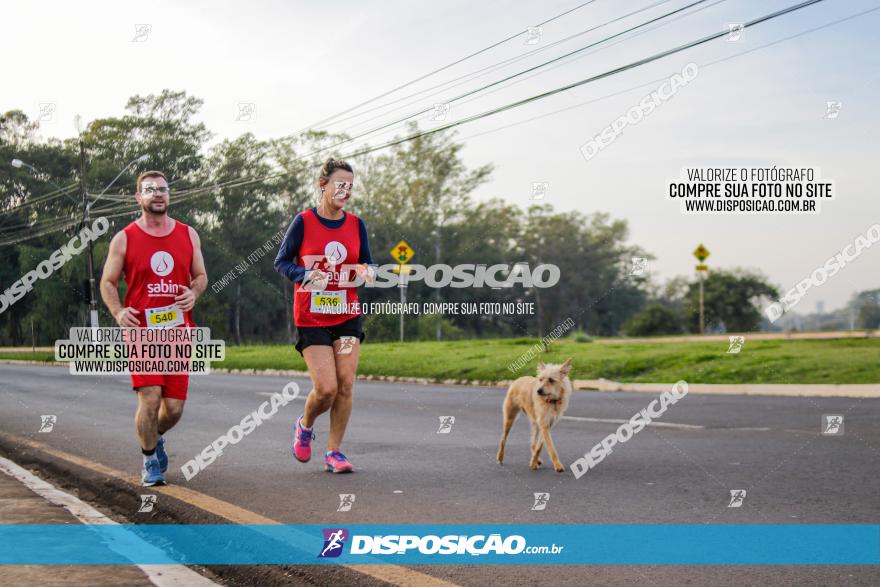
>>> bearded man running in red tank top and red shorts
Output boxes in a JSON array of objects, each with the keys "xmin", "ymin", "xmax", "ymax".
[{"xmin": 101, "ymin": 171, "xmax": 208, "ymax": 487}]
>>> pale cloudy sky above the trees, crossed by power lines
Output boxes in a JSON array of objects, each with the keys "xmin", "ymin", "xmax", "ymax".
[{"xmin": 0, "ymin": 0, "xmax": 880, "ymax": 313}]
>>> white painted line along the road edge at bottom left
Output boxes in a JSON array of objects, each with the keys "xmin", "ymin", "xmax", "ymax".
[{"xmin": 0, "ymin": 457, "xmax": 216, "ymax": 587}]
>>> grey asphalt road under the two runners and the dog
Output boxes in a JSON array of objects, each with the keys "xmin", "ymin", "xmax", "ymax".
[{"xmin": 0, "ymin": 365, "xmax": 880, "ymax": 585}]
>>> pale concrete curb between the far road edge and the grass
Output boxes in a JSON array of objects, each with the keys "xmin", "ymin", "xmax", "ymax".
[{"xmin": 0, "ymin": 359, "xmax": 880, "ymax": 398}]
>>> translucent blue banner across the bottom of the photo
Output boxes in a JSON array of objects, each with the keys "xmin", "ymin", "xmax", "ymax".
[{"xmin": 0, "ymin": 524, "xmax": 880, "ymax": 565}]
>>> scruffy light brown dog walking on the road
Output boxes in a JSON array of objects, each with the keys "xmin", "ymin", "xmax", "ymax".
[{"xmin": 498, "ymin": 358, "xmax": 572, "ymax": 473}]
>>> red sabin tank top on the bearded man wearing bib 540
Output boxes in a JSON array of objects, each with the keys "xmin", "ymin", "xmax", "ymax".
[{"xmin": 124, "ymin": 220, "xmax": 195, "ymax": 327}]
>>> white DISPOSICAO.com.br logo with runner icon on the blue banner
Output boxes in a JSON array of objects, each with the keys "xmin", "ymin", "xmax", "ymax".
[{"xmin": 318, "ymin": 528, "xmax": 564, "ymax": 558}]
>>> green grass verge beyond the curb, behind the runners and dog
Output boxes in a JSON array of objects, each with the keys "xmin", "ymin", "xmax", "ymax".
[{"xmin": 0, "ymin": 337, "xmax": 880, "ymax": 384}]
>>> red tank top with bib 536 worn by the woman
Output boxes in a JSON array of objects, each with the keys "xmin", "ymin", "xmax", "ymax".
[{"xmin": 293, "ymin": 209, "xmax": 361, "ymax": 327}]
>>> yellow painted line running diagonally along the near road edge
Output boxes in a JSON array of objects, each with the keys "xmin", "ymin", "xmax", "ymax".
[{"xmin": 0, "ymin": 432, "xmax": 457, "ymax": 587}]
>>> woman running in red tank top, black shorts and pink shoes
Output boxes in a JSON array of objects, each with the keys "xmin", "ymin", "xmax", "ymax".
[{"xmin": 275, "ymin": 158, "xmax": 374, "ymax": 473}]
